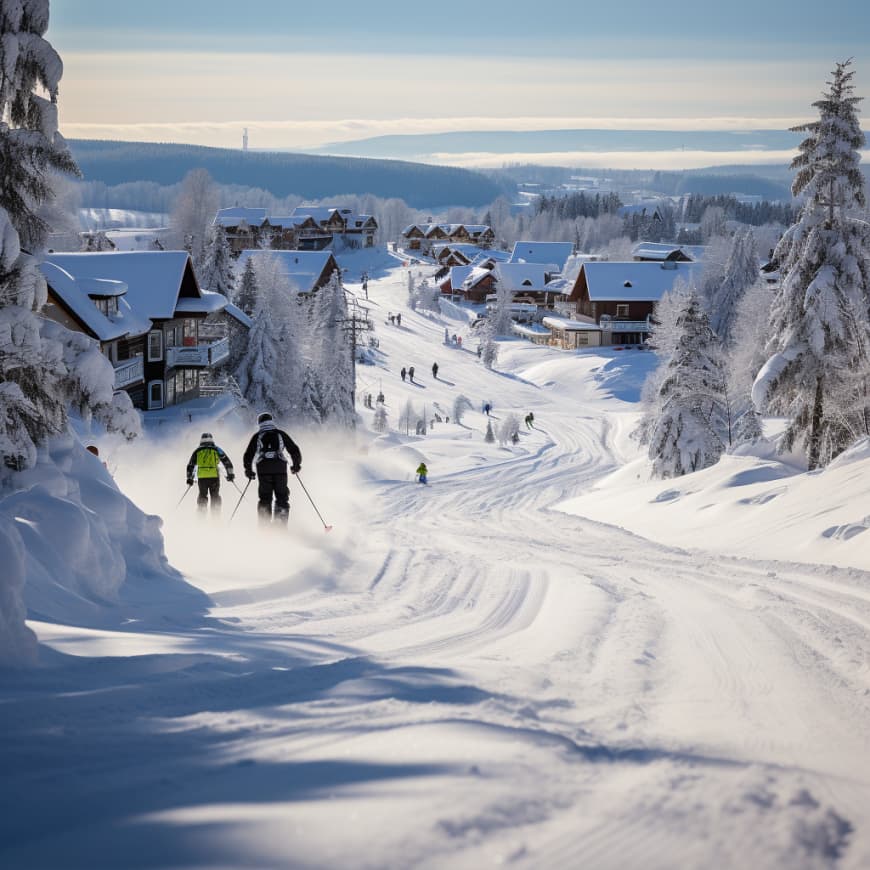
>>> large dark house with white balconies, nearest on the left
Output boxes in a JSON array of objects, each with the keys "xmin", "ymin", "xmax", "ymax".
[{"xmin": 43, "ymin": 251, "xmax": 229, "ymax": 410}]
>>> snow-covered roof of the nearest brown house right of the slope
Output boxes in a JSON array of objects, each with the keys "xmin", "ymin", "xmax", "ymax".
[{"xmin": 582, "ymin": 261, "xmax": 704, "ymax": 302}]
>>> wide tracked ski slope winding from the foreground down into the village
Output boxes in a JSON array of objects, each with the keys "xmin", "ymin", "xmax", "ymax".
[{"xmin": 0, "ymin": 255, "xmax": 870, "ymax": 870}]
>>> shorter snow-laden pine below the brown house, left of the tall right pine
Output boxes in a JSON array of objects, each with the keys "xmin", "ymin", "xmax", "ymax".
[{"xmin": 642, "ymin": 290, "xmax": 725, "ymax": 477}]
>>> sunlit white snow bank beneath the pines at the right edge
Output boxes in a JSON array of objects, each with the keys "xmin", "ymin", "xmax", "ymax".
[{"xmin": 557, "ymin": 439, "xmax": 870, "ymax": 570}]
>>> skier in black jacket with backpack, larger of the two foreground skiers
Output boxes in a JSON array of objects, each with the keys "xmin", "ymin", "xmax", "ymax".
[{"xmin": 243, "ymin": 413, "xmax": 302, "ymax": 523}]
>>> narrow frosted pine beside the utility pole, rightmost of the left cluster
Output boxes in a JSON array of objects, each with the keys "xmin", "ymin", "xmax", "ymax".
[{"xmin": 309, "ymin": 274, "xmax": 357, "ymax": 428}]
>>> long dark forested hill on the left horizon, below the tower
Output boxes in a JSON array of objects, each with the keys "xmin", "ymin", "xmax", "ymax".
[{"xmin": 69, "ymin": 139, "xmax": 506, "ymax": 209}]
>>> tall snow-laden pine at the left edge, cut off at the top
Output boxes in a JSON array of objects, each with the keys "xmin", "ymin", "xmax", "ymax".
[{"xmin": 0, "ymin": 0, "xmax": 138, "ymax": 474}]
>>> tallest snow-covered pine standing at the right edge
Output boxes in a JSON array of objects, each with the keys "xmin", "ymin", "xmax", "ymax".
[{"xmin": 753, "ymin": 61, "xmax": 870, "ymax": 469}]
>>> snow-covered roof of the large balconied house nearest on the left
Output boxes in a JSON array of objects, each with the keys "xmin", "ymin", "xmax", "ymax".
[{"xmin": 51, "ymin": 251, "xmax": 201, "ymax": 320}]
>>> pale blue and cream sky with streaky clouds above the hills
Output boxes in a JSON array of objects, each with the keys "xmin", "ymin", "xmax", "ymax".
[{"xmin": 48, "ymin": 0, "xmax": 870, "ymax": 150}]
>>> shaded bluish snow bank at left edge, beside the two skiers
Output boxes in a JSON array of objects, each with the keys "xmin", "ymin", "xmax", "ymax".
[{"xmin": 0, "ymin": 436, "xmax": 180, "ymax": 664}]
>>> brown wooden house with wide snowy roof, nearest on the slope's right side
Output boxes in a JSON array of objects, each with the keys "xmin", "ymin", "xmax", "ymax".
[{"xmin": 557, "ymin": 260, "xmax": 704, "ymax": 344}]
